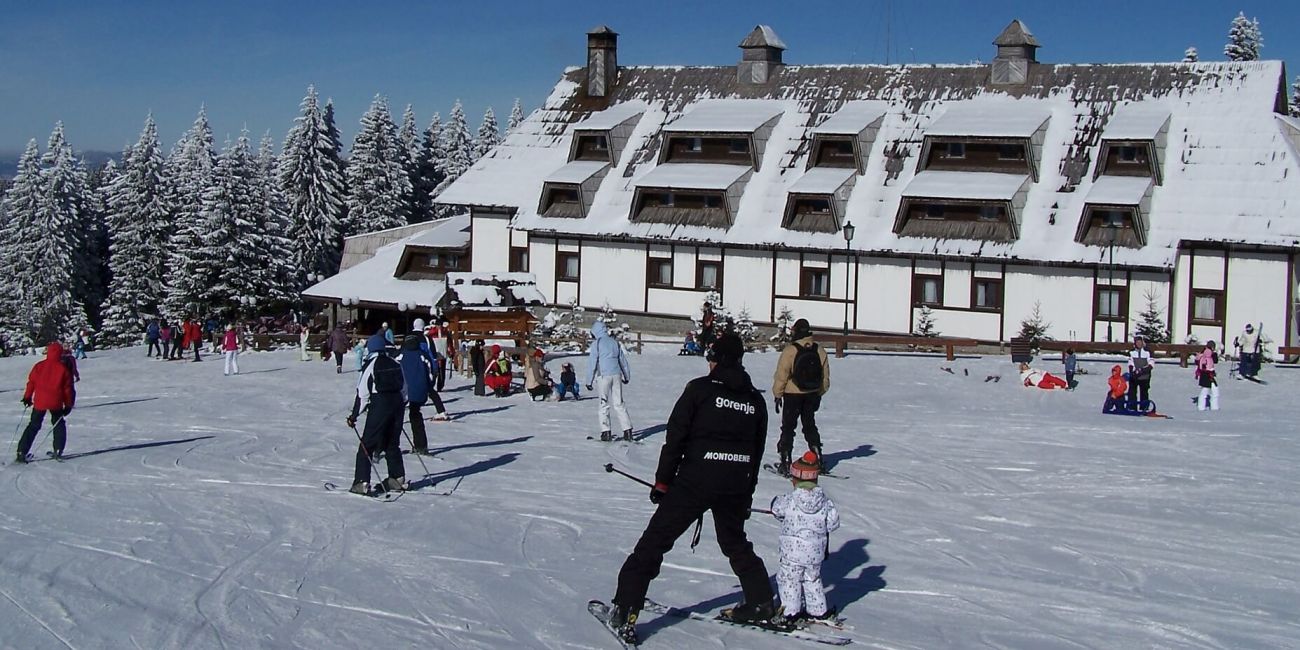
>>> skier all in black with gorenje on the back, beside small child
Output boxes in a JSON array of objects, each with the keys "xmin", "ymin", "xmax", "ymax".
[{"xmin": 610, "ymin": 333, "xmax": 775, "ymax": 638}]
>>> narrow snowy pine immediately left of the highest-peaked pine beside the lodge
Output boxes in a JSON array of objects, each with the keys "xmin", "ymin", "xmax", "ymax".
[{"xmin": 255, "ymin": 133, "xmax": 298, "ymax": 307}]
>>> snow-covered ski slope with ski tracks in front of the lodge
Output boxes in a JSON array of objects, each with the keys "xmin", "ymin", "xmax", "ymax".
[{"xmin": 0, "ymin": 346, "xmax": 1300, "ymax": 649}]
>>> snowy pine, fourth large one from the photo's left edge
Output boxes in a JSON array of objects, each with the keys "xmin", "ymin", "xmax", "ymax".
[{"xmin": 203, "ymin": 131, "xmax": 266, "ymax": 321}]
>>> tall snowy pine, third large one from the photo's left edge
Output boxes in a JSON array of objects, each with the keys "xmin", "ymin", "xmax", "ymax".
[{"xmin": 164, "ymin": 108, "xmax": 220, "ymax": 319}]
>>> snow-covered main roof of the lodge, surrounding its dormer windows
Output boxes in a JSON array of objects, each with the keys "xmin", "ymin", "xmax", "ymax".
[{"xmin": 437, "ymin": 61, "xmax": 1300, "ymax": 269}]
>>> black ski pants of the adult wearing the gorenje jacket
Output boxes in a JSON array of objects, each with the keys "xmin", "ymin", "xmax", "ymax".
[{"xmin": 614, "ymin": 486, "xmax": 772, "ymax": 611}]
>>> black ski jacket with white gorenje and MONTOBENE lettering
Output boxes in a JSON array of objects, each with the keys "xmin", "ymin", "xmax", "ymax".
[{"xmin": 654, "ymin": 365, "xmax": 767, "ymax": 495}]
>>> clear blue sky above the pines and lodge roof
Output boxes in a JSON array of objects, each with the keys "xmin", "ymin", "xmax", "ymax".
[{"xmin": 0, "ymin": 0, "xmax": 1300, "ymax": 152}]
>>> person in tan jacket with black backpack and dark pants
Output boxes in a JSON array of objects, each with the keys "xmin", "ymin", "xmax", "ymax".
[{"xmin": 772, "ymin": 319, "xmax": 831, "ymax": 476}]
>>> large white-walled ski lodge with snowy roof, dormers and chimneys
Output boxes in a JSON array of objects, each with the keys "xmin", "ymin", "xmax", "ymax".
[{"xmin": 438, "ymin": 21, "xmax": 1300, "ymax": 345}]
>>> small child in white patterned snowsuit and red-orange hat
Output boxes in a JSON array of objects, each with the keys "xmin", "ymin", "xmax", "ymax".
[{"xmin": 772, "ymin": 451, "xmax": 840, "ymax": 619}]
